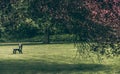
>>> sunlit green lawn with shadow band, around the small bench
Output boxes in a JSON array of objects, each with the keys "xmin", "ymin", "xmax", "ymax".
[{"xmin": 0, "ymin": 44, "xmax": 120, "ymax": 74}]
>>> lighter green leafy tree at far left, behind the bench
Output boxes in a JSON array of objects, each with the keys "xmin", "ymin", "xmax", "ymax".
[{"xmin": 1, "ymin": 0, "xmax": 38, "ymax": 39}]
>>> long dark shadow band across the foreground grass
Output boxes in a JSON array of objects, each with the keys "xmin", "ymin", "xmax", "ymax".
[{"xmin": 0, "ymin": 60, "xmax": 110, "ymax": 74}]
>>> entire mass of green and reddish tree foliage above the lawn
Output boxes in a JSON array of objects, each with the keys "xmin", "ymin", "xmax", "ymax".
[{"xmin": 0, "ymin": 0, "xmax": 120, "ymax": 57}]
